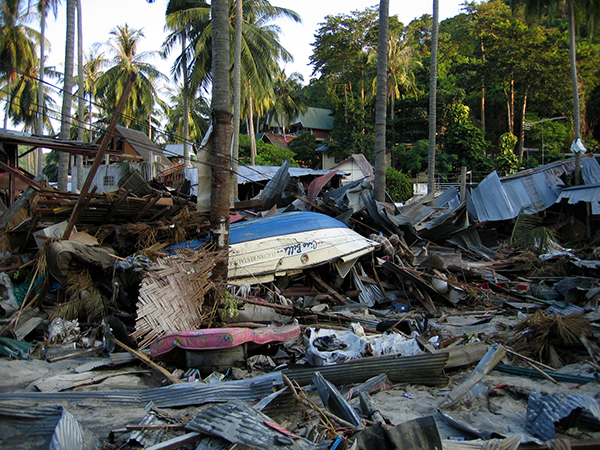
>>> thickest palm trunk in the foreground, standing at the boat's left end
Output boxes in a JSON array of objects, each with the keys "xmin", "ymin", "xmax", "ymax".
[{"xmin": 210, "ymin": 0, "xmax": 233, "ymax": 283}]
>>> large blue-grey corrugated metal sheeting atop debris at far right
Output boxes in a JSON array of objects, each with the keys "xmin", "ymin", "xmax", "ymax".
[{"xmin": 468, "ymin": 154, "xmax": 600, "ymax": 222}]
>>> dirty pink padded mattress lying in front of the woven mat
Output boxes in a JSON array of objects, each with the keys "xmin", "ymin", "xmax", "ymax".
[{"xmin": 150, "ymin": 324, "xmax": 301, "ymax": 357}]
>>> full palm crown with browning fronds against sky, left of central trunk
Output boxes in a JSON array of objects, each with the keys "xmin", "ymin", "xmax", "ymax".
[{"xmin": 97, "ymin": 24, "xmax": 166, "ymax": 128}]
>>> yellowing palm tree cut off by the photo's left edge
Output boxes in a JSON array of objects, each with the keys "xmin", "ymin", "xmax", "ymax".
[{"xmin": 0, "ymin": 0, "xmax": 39, "ymax": 128}]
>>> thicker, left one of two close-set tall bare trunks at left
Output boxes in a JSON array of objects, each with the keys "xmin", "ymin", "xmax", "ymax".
[{"xmin": 58, "ymin": 0, "xmax": 77, "ymax": 191}]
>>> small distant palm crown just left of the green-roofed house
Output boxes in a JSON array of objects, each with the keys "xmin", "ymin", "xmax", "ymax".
[{"xmin": 271, "ymin": 70, "xmax": 307, "ymax": 134}]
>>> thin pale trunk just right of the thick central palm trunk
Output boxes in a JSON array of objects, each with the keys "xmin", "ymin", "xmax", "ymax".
[{"xmin": 231, "ymin": 0, "xmax": 244, "ymax": 196}]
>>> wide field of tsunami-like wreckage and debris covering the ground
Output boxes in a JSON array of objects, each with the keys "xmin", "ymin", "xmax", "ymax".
[{"xmin": 0, "ymin": 157, "xmax": 600, "ymax": 450}]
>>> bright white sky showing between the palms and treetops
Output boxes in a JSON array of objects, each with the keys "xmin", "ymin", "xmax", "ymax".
[{"xmin": 47, "ymin": 0, "xmax": 464, "ymax": 87}]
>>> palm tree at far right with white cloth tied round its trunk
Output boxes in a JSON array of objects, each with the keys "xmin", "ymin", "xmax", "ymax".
[{"xmin": 511, "ymin": 0, "xmax": 600, "ymax": 184}]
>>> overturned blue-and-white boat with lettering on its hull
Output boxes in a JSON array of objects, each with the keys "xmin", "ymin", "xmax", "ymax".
[{"xmin": 228, "ymin": 211, "xmax": 379, "ymax": 284}]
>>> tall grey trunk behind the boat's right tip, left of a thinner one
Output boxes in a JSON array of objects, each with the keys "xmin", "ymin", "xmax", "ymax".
[{"xmin": 373, "ymin": 0, "xmax": 390, "ymax": 202}]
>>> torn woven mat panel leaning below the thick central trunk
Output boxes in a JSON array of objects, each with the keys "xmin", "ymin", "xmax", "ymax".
[{"xmin": 132, "ymin": 250, "xmax": 215, "ymax": 348}]
